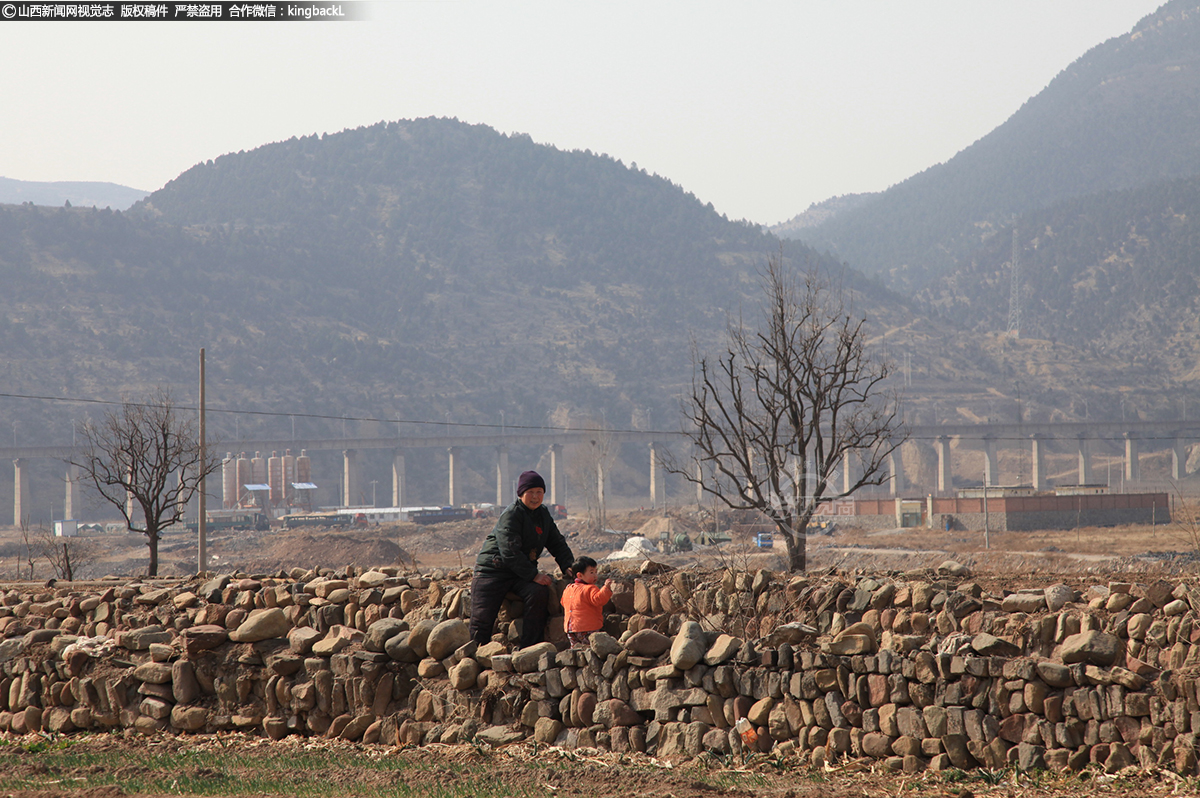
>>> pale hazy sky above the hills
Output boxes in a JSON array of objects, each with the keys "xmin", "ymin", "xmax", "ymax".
[{"xmin": 0, "ymin": 0, "xmax": 1159, "ymax": 224}]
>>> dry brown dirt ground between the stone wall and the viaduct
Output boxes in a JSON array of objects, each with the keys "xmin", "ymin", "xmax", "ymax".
[{"xmin": 0, "ymin": 505, "xmax": 1200, "ymax": 578}]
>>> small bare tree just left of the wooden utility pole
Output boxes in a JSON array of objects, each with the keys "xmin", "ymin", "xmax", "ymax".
[{"xmin": 71, "ymin": 388, "xmax": 220, "ymax": 576}]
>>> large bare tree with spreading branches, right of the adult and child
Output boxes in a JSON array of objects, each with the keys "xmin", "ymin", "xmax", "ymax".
[{"xmin": 666, "ymin": 253, "xmax": 904, "ymax": 571}]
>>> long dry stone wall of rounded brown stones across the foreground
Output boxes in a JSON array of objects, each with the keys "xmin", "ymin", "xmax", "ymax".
[{"xmin": 0, "ymin": 563, "xmax": 1200, "ymax": 774}]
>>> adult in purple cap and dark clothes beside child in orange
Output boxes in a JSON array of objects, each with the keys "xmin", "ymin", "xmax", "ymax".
[{"xmin": 470, "ymin": 472, "xmax": 575, "ymax": 648}]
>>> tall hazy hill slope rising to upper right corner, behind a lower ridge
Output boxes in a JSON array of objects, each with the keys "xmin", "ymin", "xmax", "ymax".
[{"xmin": 781, "ymin": 0, "xmax": 1200, "ymax": 289}]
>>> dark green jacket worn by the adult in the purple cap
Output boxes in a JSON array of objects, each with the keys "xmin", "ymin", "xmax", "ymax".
[{"xmin": 475, "ymin": 499, "xmax": 575, "ymax": 582}]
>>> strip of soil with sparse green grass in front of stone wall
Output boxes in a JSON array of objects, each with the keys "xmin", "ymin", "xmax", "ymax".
[{"xmin": 0, "ymin": 734, "xmax": 1185, "ymax": 798}]
